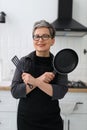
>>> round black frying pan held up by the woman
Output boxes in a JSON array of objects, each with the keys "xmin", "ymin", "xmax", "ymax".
[{"xmin": 53, "ymin": 48, "xmax": 79, "ymax": 75}]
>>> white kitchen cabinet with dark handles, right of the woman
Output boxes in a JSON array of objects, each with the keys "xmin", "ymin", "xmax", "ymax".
[{"xmin": 60, "ymin": 93, "xmax": 87, "ymax": 130}]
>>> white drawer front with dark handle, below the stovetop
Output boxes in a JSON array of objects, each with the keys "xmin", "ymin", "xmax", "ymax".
[{"xmin": 60, "ymin": 93, "xmax": 87, "ymax": 115}]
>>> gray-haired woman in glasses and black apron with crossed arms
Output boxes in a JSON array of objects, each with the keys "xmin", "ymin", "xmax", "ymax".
[{"xmin": 11, "ymin": 20, "xmax": 68, "ymax": 130}]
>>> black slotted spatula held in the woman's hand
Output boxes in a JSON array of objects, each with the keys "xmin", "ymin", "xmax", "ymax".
[{"xmin": 11, "ymin": 55, "xmax": 33, "ymax": 89}]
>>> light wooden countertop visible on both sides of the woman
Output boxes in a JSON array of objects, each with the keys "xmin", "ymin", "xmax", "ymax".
[{"xmin": 0, "ymin": 86, "xmax": 87, "ymax": 93}]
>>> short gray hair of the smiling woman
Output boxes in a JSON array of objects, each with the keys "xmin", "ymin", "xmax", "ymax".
[{"xmin": 32, "ymin": 20, "xmax": 55, "ymax": 38}]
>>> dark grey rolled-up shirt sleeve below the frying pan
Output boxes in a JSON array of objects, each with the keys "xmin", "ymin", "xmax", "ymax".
[{"xmin": 51, "ymin": 74, "xmax": 68, "ymax": 100}]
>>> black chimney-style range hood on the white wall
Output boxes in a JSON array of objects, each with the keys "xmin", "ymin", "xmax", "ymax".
[{"xmin": 52, "ymin": 0, "xmax": 87, "ymax": 37}]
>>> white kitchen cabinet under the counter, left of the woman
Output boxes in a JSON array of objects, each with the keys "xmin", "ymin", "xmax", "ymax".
[{"xmin": 0, "ymin": 91, "xmax": 17, "ymax": 130}]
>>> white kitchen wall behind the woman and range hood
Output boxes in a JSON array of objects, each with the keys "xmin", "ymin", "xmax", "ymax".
[{"xmin": 0, "ymin": 0, "xmax": 87, "ymax": 82}]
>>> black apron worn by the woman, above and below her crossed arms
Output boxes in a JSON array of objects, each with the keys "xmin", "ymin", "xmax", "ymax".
[{"xmin": 17, "ymin": 52, "xmax": 63, "ymax": 130}]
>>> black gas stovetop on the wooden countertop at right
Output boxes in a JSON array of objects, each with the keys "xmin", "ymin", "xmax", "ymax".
[{"xmin": 68, "ymin": 80, "xmax": 87, "ymax": 88}]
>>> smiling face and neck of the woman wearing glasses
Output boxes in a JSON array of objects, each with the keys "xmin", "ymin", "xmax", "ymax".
[{"xmin": 33, "ymin": 27, "xmax": 55, "ymax": 57}]
